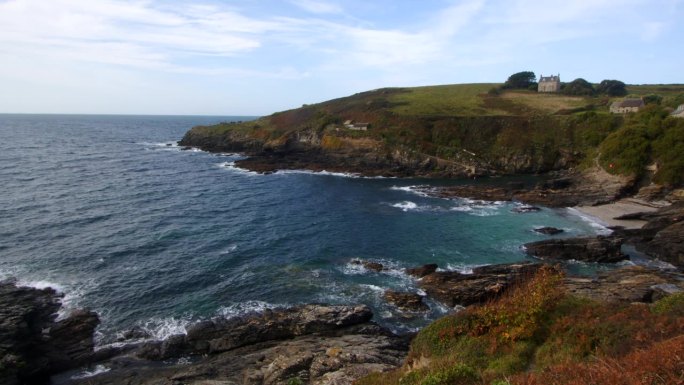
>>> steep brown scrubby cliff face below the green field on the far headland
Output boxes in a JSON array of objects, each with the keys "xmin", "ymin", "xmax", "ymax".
[{"xmin": 179, "ymin": 116, "xmax": 578, "ymax": 177}]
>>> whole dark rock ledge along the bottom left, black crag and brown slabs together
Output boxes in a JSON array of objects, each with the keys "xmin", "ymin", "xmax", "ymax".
[{"xmin": 0, "ymin": 282, "xmax": 408, "ymax": 385}]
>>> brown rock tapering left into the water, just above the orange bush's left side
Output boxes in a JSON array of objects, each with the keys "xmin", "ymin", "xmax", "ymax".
[{"xmin": 420, "ymin": 263, "xmax": 542, "ymax": 307}]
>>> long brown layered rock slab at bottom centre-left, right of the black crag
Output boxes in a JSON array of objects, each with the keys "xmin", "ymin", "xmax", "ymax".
[{"xmin": 64, "ymin": 305, "xmax": 408, "ymax": 385}]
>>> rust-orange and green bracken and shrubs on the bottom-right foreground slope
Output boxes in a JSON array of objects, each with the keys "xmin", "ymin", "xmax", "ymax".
[{"xmin": 356, "ymin": 267, "xmax": 684, "ymax": 385}]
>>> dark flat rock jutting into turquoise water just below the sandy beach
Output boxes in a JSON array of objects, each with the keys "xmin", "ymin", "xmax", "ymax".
[{"xmin": 525, "ymin": 236, "xmax": 627, "ymax": 263}]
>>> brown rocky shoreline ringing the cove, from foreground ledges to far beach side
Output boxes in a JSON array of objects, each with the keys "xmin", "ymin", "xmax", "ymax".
[{"xmin": 0, "ymin": 160, "xmax": 684, "ymax": 385}]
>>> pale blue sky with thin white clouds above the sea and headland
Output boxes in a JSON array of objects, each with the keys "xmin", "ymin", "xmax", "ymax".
[{"xmin": 0, "ymin": 0, "xmax": 684, "ymax": 115}]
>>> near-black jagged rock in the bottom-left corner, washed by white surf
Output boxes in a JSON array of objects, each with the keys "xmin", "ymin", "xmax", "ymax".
[{"xmin": 0, "ymin": 282, "xmax": 99, "ymax": 384}]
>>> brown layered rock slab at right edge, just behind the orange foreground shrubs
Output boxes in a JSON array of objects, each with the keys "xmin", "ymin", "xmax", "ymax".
[{"xmin": 564, "ymin": 266, "xmax": 684, "ymax": 303}]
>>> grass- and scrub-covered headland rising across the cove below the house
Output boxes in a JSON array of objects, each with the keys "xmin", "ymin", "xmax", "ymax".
[{"xmin": 184, "ymin": 83, "xmax": 684, "ymax": 185}]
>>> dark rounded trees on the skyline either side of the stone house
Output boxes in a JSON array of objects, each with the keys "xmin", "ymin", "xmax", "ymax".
[{"xmin": 501, "ymin": 71, "xmax": 627, "ymax": 96}]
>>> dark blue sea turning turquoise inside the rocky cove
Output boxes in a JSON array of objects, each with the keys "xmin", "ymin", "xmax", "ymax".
[{"xmin": 0, "ymin": 115, "xmax": 602, "ymax": 344}]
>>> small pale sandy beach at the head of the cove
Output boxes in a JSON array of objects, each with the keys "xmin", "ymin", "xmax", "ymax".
[{"xmin": 574, "ymin": 198, "xmax": 663, "ymax": 229}]
